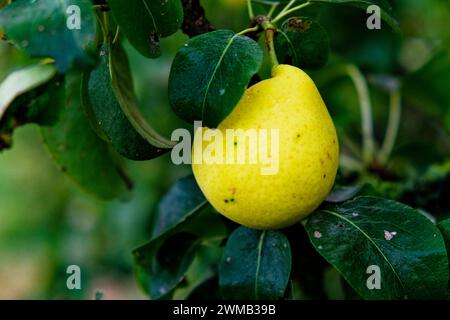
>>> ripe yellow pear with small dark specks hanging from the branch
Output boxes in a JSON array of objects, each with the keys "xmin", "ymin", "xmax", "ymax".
[{"xmin": 192, "ymin": 65, "xmax": 339, "ymax": 229}]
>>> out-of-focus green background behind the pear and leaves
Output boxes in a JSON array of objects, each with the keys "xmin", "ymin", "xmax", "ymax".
[{"xmin": 0, "ymin": 0, "xmax": 450, "ymax": 299}]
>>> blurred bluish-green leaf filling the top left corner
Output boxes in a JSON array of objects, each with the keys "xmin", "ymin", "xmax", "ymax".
[{"xmin": 0, "ymin": 0, "xmax": 97, "ymax": 73}]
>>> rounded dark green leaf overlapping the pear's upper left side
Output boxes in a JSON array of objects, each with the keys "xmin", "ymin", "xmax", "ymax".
[{"xmin": 169, "ymin": 30, "xmax": 263, "ymax": 127}]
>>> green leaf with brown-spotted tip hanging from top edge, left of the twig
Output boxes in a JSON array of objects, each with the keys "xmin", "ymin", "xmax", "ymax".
[{"xmin": 108, "ymin": 0, "xmax": 183, "ymax": 58}]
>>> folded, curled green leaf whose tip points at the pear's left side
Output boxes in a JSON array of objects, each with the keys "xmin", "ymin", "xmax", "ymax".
[{"xmin": 82, "ymin": 45, "xmax": 170, "ymax": 160}]
